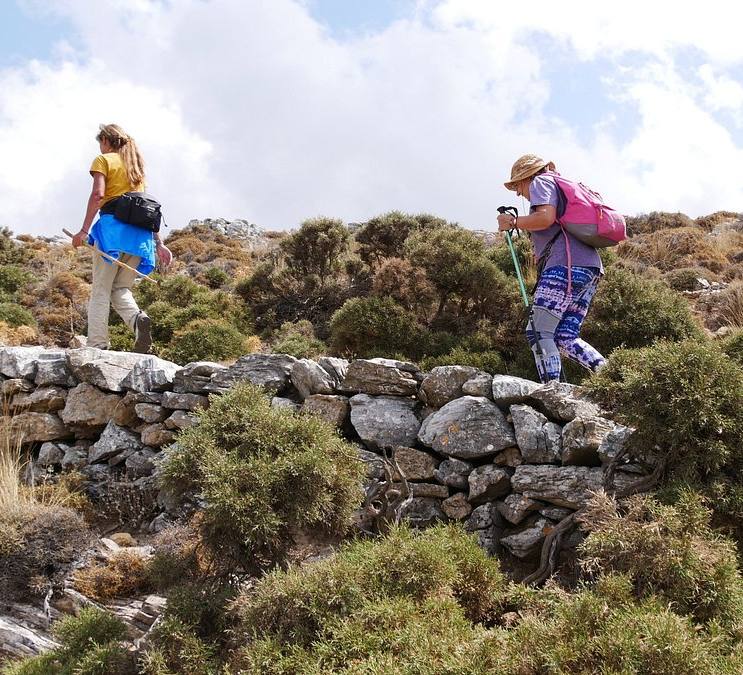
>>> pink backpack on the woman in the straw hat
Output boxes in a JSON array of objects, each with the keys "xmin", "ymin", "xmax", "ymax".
[{"xmin": 544, "ymin": 171, "xmax": 627, "ymax": 248}]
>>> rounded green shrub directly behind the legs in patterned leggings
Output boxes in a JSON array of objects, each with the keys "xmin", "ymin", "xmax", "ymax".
[{"xmin": 582, "ymin": 266, "xmax": 702, "ymax": 356}]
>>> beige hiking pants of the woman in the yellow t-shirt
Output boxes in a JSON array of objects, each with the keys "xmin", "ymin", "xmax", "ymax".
[{"xmin": 88, "ymin": 253, "xmax": 140, "ymax": 349}]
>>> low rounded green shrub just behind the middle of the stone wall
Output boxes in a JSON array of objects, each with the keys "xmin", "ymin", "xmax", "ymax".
[{"xmin": 330, "ymin": 297, "xmax": 421, "ymax": 358}]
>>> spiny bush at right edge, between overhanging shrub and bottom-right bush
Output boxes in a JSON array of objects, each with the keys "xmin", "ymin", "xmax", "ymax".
[{"xmin": 579, "ymin": 490, "xmax": 743, "ymax": 628}]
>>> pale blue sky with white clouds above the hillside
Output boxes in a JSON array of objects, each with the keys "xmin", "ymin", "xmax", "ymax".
[{"xmin": 0, "ymin": 0, "xmax": 743, "ymax": 238}]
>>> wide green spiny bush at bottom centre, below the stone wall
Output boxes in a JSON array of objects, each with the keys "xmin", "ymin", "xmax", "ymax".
[{"xmin": 233, "ymin": 526, "xmax": 506, "ymax": 673}]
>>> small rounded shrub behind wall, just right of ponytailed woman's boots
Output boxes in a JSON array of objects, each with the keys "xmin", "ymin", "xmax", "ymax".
[{"xmin": 161, "ymin": 319, "xmax": 246, "ymax": 364}]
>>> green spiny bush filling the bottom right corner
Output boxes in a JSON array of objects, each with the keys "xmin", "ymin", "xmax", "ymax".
[{"xmin": 480, "ymin": 576, "xmax": 743, "ymax": 675}]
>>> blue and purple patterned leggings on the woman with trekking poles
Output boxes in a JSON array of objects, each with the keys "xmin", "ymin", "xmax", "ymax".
[{"xmin": 526, "ymin": 265, "xmax": 606, "ymax": 382}]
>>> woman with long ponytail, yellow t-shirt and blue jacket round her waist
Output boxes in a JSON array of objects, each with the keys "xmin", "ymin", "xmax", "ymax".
[{"xmin": 72, "ymin": 124, "xmax": 172, "ymax": 354}]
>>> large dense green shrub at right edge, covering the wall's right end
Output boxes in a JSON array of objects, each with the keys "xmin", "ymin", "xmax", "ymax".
[{"xmin": 587, "ymin": 340, "xmax": 743, "ymax": 476}]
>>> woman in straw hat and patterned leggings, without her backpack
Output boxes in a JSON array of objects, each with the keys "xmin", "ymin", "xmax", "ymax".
[{"xmin": 498, "ymin": 155, "xmax": 605, "ymax": 382}]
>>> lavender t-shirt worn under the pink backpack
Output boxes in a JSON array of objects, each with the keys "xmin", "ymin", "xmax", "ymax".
[{"xmin": 529, "ymin": 175, "xmax": 604, "ymax": 272}]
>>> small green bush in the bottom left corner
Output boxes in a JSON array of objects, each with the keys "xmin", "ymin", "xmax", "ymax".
[{"xmin": 3, "ymin": 607, "xmax": 137, "ymax": 675}]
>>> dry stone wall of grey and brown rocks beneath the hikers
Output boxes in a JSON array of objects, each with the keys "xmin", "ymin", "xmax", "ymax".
[{"xmin": 0, "ymin": 347, "xmax": 643, "ymax": 559}]
